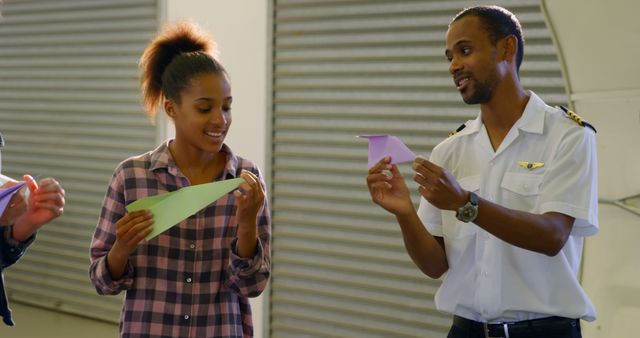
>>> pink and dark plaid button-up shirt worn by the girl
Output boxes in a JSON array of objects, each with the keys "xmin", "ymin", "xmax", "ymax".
[{"xmin": 89, "ymin": 141, "xmax": 271, "ymax": 338}]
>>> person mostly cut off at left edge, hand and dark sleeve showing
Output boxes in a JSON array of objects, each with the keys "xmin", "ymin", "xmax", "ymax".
[{"xmin": 0, "ymin": 135, "xmax": 65, "ymax": 326}]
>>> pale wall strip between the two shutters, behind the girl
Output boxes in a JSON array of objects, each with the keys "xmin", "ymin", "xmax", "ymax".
[{"xmin": 162, "ymin": 0, "xmax": 270, "ymax": 338}]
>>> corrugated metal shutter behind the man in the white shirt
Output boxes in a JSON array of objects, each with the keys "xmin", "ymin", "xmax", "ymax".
[{"xmin": 270, "ymin": 0, "xmax": 566, "ymax": 337}]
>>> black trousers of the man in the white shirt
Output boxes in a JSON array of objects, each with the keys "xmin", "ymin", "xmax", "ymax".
[{"xmin": 447, "ymin": 316, "xmax": 582, "ymax": 338}]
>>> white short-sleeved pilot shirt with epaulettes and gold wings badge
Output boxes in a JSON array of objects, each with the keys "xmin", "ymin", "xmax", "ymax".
[{"xmin": 418, "ymin": 92, "xmax": 598, "ymax": 322}]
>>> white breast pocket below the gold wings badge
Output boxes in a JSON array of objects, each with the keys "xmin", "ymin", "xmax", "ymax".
[{"xmin": 500, "ymin": 173, "xmax": 542, "ymax": 212}]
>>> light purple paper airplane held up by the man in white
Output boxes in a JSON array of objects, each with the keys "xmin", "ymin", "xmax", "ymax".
[{"xmin": 358, "ymin": 134, "xmax": 416, "ymax": 168}]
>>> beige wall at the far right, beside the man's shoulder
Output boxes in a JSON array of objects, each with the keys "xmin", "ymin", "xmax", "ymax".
[{"xmin": 542, "ymin": 0, "xmax": 640, "ymax": 338}]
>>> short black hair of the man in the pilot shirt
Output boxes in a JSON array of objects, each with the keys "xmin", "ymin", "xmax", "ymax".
[{"xmin": 449, "ymin": 6, "xmax": 524, "ymax": 74}]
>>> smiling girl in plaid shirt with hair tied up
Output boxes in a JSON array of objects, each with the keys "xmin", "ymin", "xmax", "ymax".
[{"xmin": 89, "ymin": 23, "xmax": 271, "ymax": 338}]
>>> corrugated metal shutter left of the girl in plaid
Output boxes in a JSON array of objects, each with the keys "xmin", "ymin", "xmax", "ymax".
[{"xmin": 0, "ymin": 0, "xmax": 158, "ymax": 322}]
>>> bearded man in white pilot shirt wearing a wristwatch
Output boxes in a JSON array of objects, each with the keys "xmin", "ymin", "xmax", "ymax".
[{"xmin": 367, "ymin": 6, "xmax": 598, "ymax": 338}]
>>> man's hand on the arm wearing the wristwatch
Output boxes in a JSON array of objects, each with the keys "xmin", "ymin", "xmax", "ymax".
[{"xmin": 413, "ymin": 156, "xmax": 469, "ymax": 210}]
